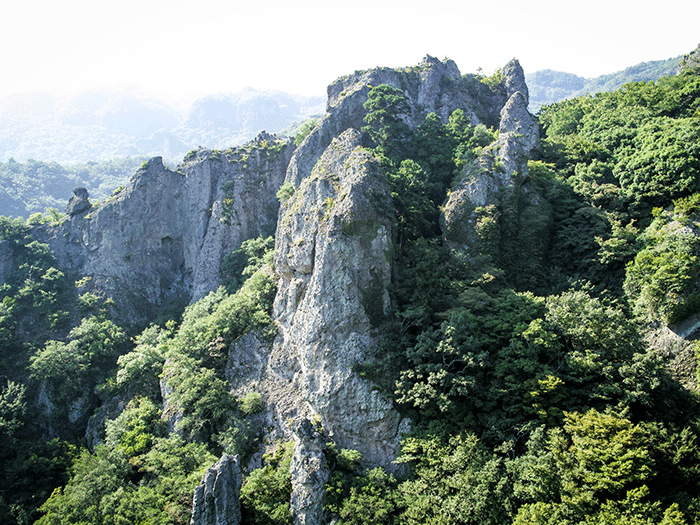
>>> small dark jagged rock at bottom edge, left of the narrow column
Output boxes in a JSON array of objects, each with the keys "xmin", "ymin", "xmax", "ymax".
[{"xmin": 190, "ymin": 454, "xmax": 243, "ymax": 525}]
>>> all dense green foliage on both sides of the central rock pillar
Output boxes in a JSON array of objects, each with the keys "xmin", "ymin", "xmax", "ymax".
[{"xmin": 0, "ymin": 58, "xmax": 700, "ymax": 525}]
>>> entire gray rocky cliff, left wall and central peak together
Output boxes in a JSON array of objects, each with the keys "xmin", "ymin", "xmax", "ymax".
[{"xmin": 28, "ymin": 57, "xmax": 539, "ymax": 523}]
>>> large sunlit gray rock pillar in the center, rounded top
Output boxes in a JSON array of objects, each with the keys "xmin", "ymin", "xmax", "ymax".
[{"xmin": 261, "ymin": 130, "xmax": 400, "ymax": 467}]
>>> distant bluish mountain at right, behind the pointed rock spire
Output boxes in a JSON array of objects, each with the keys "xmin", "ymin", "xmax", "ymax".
[{"xmin": 525, "ymin": 56, "xmax": 683, "ymax": 113}]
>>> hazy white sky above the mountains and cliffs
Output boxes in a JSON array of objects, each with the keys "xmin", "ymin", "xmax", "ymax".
[{"xmin": 0, "ymin": 0, "xmax": 700, "ymax": 102}]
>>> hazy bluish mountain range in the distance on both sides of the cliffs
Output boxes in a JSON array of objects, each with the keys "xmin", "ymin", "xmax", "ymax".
[{"xmin": 0, "ymin": 52, "xmax": 683, "ymax": 218}]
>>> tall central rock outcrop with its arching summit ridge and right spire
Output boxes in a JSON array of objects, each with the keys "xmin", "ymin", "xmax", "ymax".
[{"xmin": 198, "ymin": 57, "xmax": 539, "ymax": 524}]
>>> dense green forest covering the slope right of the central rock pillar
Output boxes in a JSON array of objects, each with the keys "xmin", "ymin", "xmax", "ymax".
[{"xmin": 328, "ymin": 72, "xmax": 700, "ymax": 524}]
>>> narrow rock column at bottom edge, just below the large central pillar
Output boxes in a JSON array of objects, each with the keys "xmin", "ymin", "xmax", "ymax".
[{"xmin": 290, "ymin": 419, "xmax": 330, "ymax": 525}]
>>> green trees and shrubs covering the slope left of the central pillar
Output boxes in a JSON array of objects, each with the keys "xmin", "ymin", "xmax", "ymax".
[{"xmin": 0, "ymin": 227, "xmax": 278, "ymax": 524}]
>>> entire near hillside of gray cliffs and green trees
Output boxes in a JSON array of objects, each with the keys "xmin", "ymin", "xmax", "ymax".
[{"xmin": 0, "ymin": 50, "xmax": 700, "ymax": 525}]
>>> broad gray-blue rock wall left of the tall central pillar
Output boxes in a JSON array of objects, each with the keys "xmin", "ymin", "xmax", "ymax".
[{"xmin": 39, "ymin": 134, "xmax": 294, "ymax": 323}]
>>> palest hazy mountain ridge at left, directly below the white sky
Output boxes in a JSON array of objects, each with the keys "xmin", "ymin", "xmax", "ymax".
[{"xmin": 0, "ymin": 88, "xmax": 325, "ymax": 164}]
